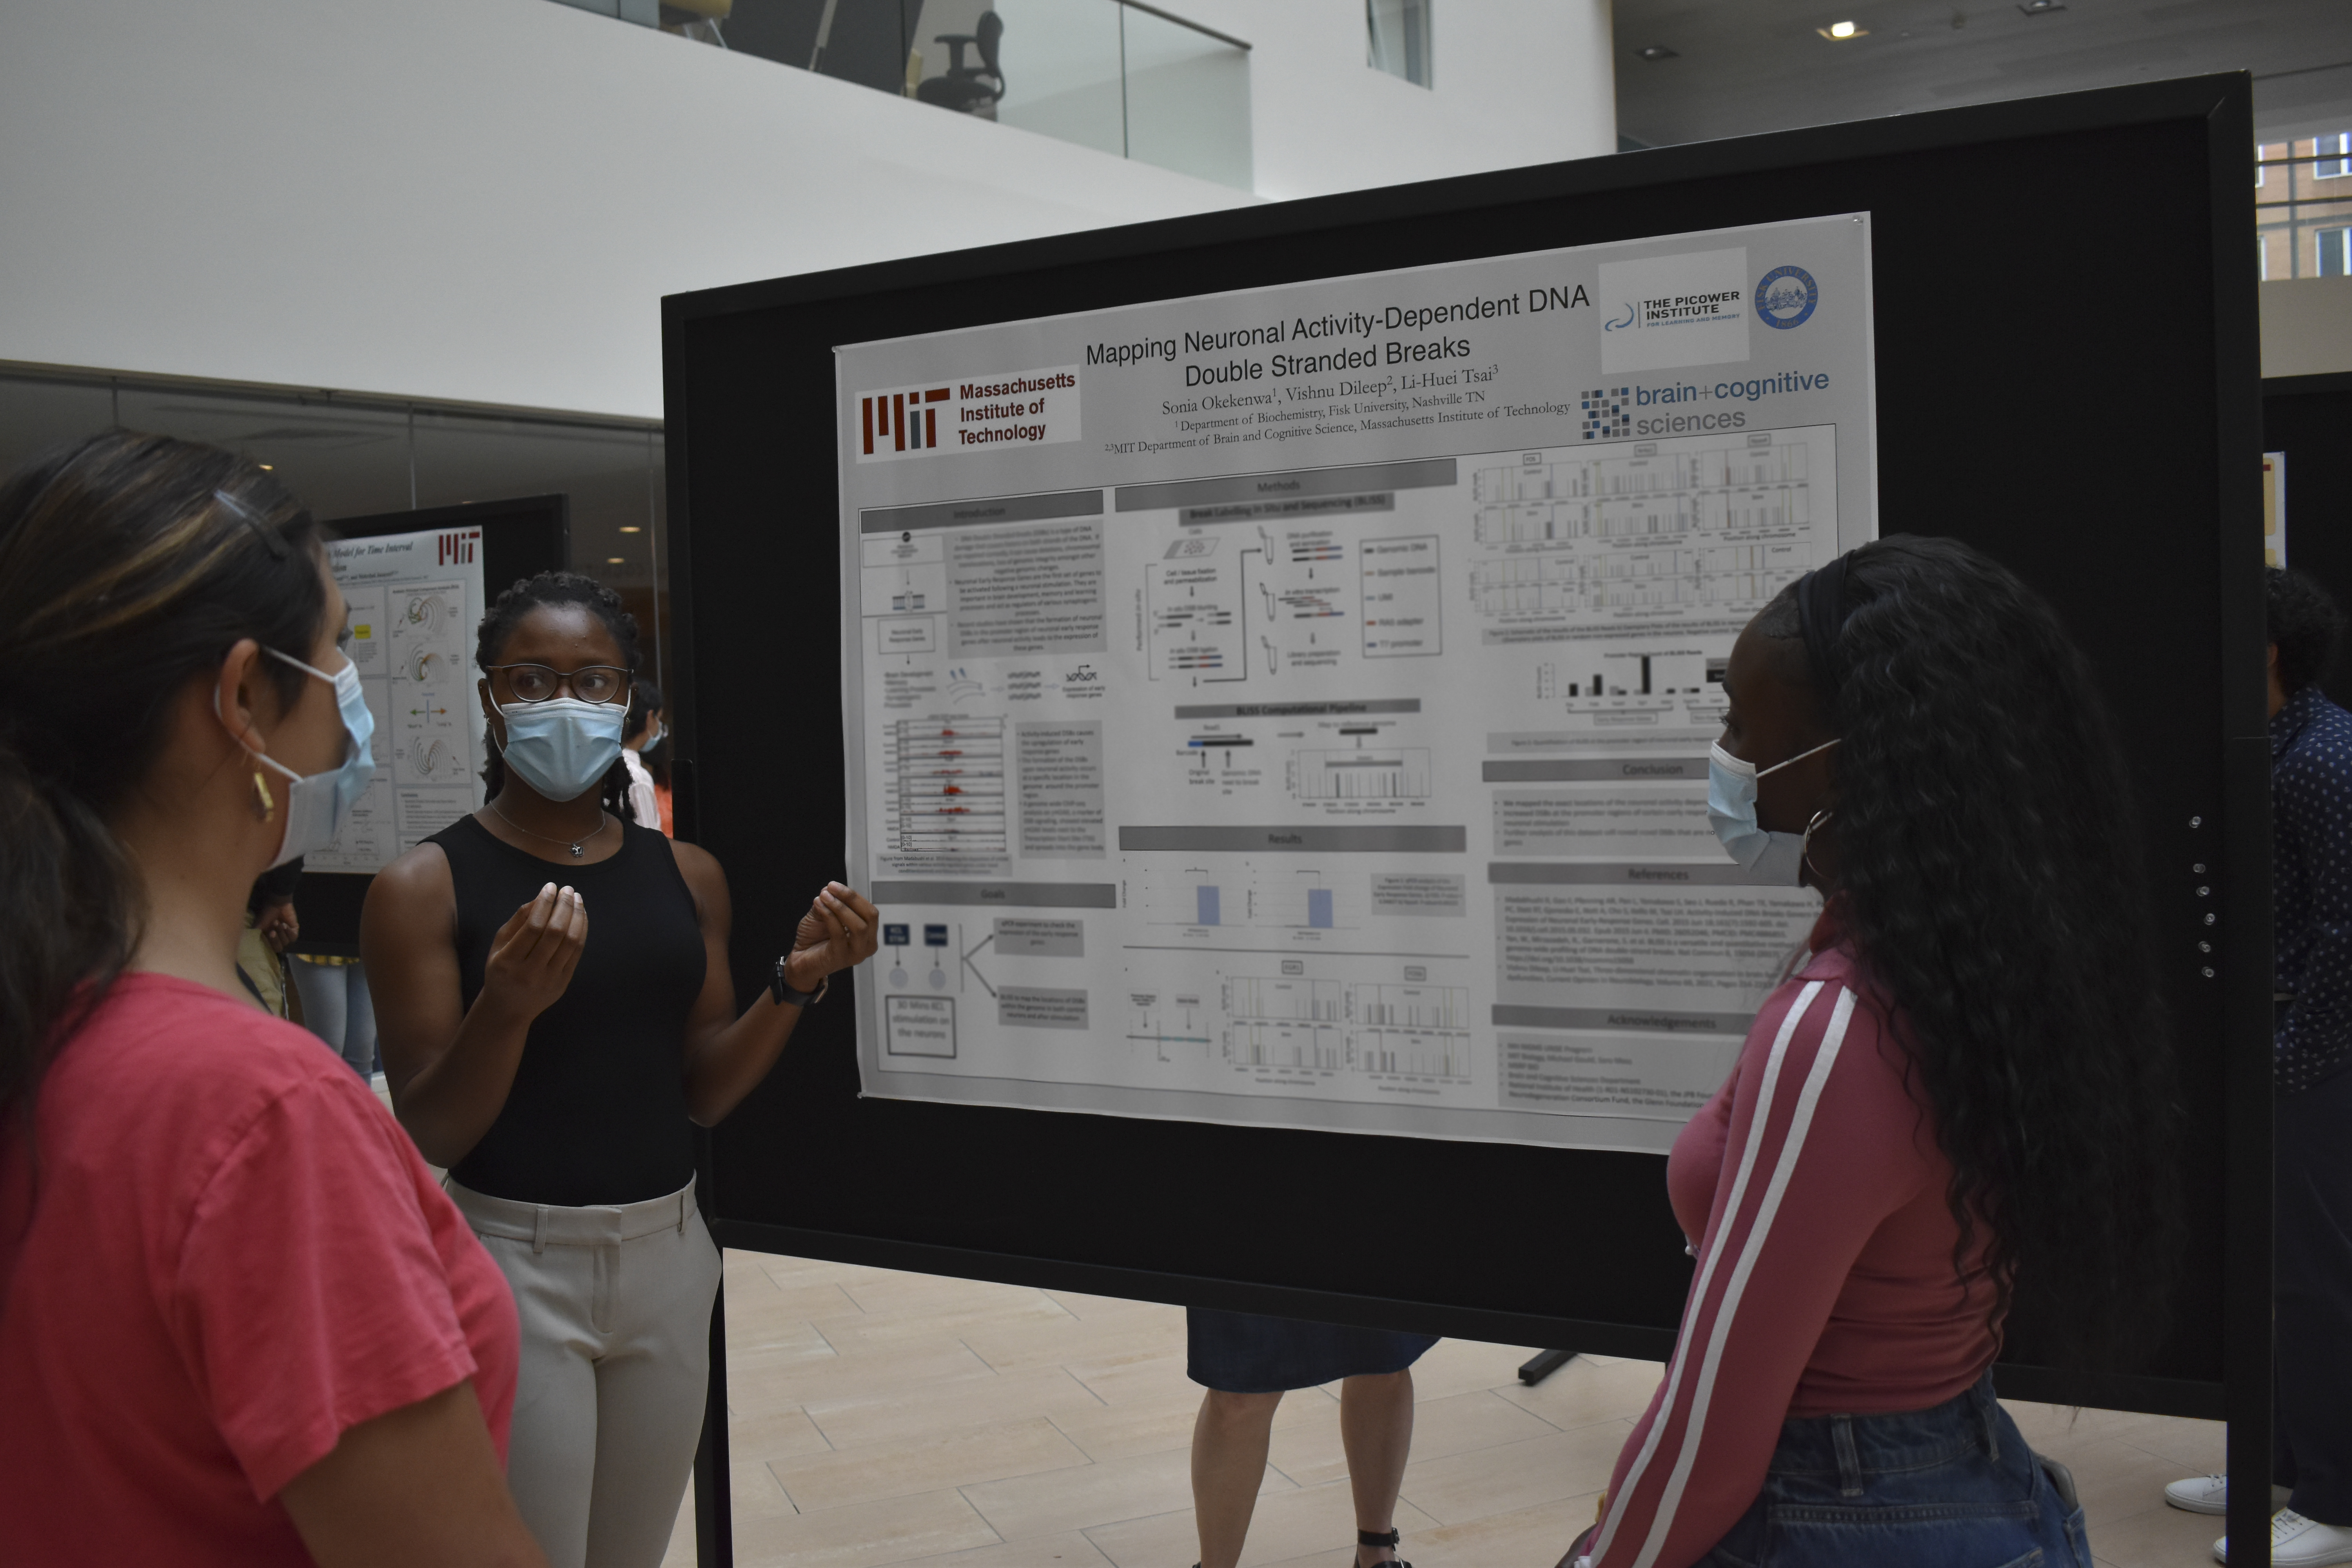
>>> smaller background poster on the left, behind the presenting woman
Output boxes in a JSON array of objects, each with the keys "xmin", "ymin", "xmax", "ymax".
[{"xmin": 303, "ymin": 529, "xmax": 485, "ymax": 872}]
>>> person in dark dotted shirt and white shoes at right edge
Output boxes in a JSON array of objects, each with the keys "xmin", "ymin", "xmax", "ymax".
[{"xmin": 2164, "ymin": 566, "xmax": 2352, "ymax": 1568}]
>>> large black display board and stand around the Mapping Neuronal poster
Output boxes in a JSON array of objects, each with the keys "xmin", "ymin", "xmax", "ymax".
[{"xmin": 663, "ymin": 75, "xmax": 2293, "ymax": 1563}]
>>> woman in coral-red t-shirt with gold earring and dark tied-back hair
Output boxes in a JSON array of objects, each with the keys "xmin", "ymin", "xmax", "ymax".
[{"xmin": 0, "ymin": 432, "xmax": 546, "ymax": 1568}]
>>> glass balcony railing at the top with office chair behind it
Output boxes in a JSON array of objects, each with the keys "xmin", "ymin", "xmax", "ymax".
[{"xmin": 576, "ymin": 0, "xmax": 1251, "ymax": 191}]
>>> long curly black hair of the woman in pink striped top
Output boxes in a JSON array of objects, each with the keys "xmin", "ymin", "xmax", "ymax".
[{"xmin": 1757, "ymin": 536, "xmax": 2180, "ymax": 1366}]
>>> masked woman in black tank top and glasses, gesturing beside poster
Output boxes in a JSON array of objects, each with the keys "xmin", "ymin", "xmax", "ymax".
[{"xmin": 360, "ymin": 571, "xmax": 880, "ymax": 1568}]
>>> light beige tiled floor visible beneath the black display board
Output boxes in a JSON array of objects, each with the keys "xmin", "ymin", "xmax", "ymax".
[{"xmin": 668, "ymin": 1253, "xmax": 2223, "ymax": 1568}]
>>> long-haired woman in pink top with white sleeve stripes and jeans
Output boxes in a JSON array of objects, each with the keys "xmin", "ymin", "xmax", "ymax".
[{"xmin": 1569, "ymin": 536, "xmax": 2178, "ymax": 1568}]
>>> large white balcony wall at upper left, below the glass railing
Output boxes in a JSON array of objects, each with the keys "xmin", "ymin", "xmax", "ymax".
[{"xmin": 0, "ymin": 0, "xmax": 1251, "ymax": 416}]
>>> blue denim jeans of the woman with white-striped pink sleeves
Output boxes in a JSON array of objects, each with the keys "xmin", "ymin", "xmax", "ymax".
[{"xmin": 1700, "ymin": 1373, "xmax": 2091, "ymax": 1568}]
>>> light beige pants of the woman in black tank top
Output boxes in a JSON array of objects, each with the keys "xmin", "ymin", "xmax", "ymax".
[{"xmin": 449, "ymin": 1180, "xmax": 720, "ymax": 1568}]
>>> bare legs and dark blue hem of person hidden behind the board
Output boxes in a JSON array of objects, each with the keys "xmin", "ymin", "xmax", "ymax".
[{"xmin": 1185, "ymin": 1307, "xmax": 1437, "ymax": 1568}]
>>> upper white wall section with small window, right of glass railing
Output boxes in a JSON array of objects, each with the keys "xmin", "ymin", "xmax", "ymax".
[{"xmin": 1162, "ymin": 0, "xmax": 1616, "ymax": 200}]
